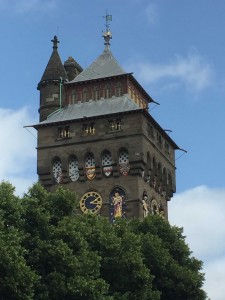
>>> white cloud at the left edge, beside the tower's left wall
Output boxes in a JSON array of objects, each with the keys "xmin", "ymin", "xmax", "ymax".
[{"xmin": 0, "ymin": 108, "xmax": 37, "ymax": 194}]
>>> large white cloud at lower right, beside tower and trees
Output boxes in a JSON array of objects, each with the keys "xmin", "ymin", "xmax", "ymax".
[{"xmin": 169, "ymin": 186, "xmax": 225, "ymax": 300}]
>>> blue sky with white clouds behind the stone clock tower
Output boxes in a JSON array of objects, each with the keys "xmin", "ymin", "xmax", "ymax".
[{"xmin": 0, "ymin": 0, "xmax": 225, "ymax": 300}]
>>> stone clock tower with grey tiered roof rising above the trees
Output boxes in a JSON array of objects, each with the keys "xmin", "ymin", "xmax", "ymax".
[{"xmin": 34, "ymin": 23, "xmax": 179, "ymax": 222}]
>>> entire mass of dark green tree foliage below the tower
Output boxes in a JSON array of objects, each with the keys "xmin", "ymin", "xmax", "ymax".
[{"xmin": 0, "ymin": 182, "xmax": 206, "ymax": 300}]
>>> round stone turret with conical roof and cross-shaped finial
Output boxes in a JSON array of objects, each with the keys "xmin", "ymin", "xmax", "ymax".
[{"xmin": 37, "ymin": 36, "xmax": 68, "ymax": 121}]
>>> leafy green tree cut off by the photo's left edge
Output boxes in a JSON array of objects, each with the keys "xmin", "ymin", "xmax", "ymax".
[{"xmin": 0, "ymin": 182, "xmax": 37, "ymax": 300}]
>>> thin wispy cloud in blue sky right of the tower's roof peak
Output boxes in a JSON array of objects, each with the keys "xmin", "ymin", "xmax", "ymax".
[{"xmin": 128, "ymin": 50, "xmax": 213, "ymax": 92}]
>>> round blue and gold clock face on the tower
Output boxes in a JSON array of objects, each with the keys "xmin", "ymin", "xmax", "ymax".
[{"xmin": 80, "ymin": 191, "xmax": 102, "ymax": 214}]
